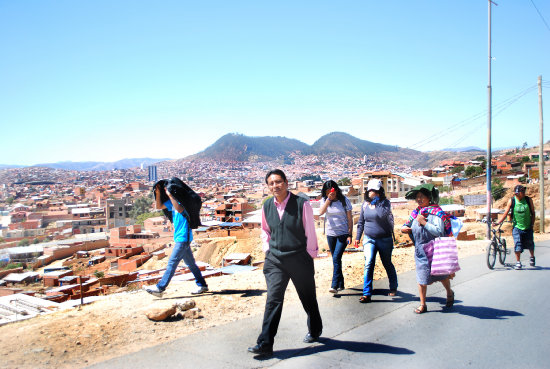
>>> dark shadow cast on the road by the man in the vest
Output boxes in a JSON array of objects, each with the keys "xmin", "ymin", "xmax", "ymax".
[{"xmin": 254, "ymin": 337, "xmax": 415, "ymax": 360}]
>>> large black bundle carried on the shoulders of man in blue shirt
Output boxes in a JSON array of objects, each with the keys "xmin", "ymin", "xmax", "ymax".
[{"xmin": 153, "ymin": 177, "xmax": 202, "ymax": 229}]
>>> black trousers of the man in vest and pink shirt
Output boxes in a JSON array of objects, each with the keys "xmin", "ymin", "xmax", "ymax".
[{"xmin": 258, "ymin": 251, "xmax": 323, "ymax": 345}]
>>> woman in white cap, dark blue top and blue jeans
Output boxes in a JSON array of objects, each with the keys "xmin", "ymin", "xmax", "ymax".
[{"xmin": 355, "ymin": 179, "xmax": 397, "ymax": 303}]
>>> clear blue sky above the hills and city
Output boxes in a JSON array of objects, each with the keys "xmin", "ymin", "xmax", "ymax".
[{"xmin": 0, "ymin": 0, "xmax": 550, "ymax": 165}]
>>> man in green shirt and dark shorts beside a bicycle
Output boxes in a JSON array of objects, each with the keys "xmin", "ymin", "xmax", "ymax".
[{"xmin": 497, "ymin": 185, "xmax": 535, "ymax": 270}]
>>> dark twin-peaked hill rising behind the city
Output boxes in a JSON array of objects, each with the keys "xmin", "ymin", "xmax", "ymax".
[{"xmin": 194, "ymin": 132, "xmax": 398, "ymax": 161}]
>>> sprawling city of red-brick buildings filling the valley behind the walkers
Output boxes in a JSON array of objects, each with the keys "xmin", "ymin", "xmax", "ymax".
[{"xmin": 0, "ymin": 148, "xmax": 550, "ymax": 325}]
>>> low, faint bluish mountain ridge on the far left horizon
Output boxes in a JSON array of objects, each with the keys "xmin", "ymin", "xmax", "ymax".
[{"xmin": 0, "ymin": 158, "xmax": 170, "ymax": 171}]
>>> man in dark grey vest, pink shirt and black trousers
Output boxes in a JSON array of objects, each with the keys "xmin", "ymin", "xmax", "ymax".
[{"xmin": 248, "ymin": 169, "xmax": 323, "ymax": 355}]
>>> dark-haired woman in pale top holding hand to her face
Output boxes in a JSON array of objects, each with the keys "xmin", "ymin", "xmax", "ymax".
[{"xmin": 319, "ymin": 181, "xmax": 353, "ymax": 294}]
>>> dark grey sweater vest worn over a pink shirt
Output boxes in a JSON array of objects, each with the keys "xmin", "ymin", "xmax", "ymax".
[{"xmin": 264, "ymin": 193, "xmax": 307, "ymax": 257}]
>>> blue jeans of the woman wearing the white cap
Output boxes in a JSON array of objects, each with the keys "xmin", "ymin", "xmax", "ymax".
[{"xmin": 363, "ymin": 235, "xmax": 397, "ymax": 296}]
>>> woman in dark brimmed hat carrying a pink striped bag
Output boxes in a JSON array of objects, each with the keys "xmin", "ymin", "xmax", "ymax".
[{"xmin": 401, "ymin": 184, "xmax": 454, "ymax": 314}]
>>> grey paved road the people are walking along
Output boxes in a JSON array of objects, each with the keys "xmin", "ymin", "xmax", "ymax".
[{"xmin": 91, "ymin": 241, "xmax": 550, "ymax": 369}]
